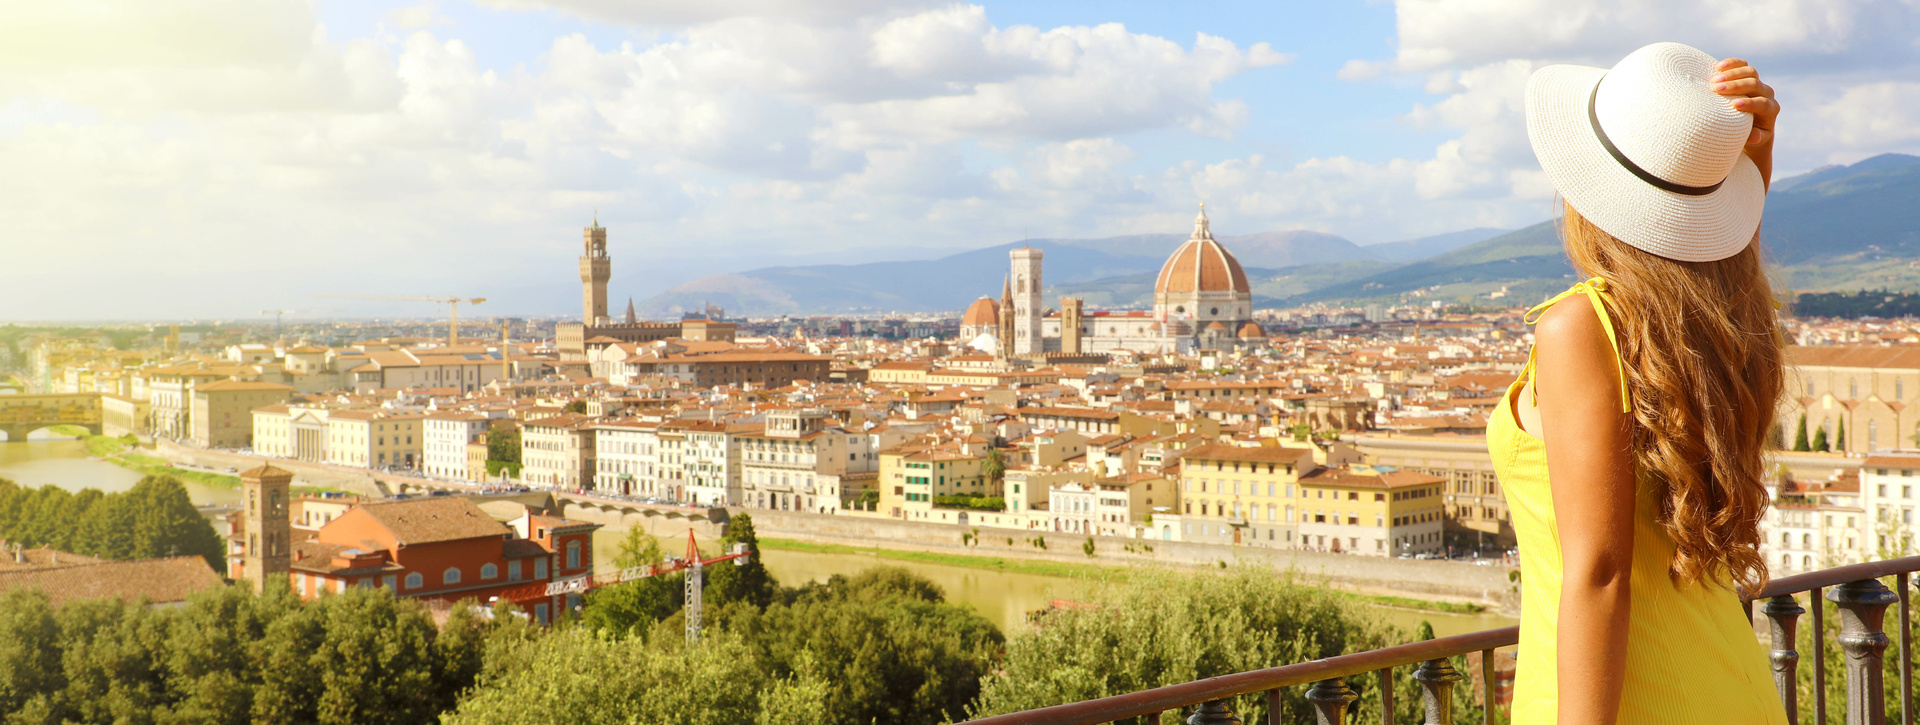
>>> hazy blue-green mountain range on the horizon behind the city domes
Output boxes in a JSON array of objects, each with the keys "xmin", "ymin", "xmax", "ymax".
[{"xmin": 643, "ymin": 153, "xmax": 1920, "ymax": 315}]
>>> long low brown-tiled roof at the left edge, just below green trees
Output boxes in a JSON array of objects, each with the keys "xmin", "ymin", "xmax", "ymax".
[{"xmin": 0, "ymin": 556, "xmax": 225, "ymax": 606}]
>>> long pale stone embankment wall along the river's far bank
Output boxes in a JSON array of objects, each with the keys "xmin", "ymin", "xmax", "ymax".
[{"xmin": 733, "ymin": 508, "xmax": 1519, "ymax": 614}]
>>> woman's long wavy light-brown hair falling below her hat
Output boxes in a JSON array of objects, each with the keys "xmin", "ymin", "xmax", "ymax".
[{"xmin": 1561, "ymin": 205, "xmax": 1786, "ymax": 591}]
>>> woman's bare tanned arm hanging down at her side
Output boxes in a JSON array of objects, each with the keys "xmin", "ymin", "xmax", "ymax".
[{"xmin": 1534, "ymin": 297, "xmax": 1634, "ymax": 725}]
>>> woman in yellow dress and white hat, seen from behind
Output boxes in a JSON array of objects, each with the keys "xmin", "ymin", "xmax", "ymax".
[{"xmin": 1488, "ymin": 42, "xmax": 1786, "ymax": 725}]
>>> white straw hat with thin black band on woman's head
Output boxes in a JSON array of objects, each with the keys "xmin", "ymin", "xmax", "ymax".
[{"xmin": 1526, "ymin": 42, "xmax": 1766, "ymax": 261}]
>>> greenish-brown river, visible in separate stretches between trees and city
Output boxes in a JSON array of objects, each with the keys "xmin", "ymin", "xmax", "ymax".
[{"xmin": 0, "ymin": 439, "xmax": 1517, "ymax": 637}]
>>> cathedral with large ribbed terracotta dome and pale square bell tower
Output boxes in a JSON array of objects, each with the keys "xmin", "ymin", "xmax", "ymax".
[{"xmin": 960, "ymin": 203, "xmax": 1267, "ymax": 357}]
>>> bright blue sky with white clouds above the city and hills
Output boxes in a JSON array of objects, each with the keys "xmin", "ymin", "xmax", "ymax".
[{"xmin": 0, "ymin": 0, "xmax": 1920, "ymax": 320}]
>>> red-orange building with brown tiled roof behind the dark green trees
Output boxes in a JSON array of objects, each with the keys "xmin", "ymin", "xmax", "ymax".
[{"xmin": 290, "ymin": 497, "xmax": 599, "ymax": 623}]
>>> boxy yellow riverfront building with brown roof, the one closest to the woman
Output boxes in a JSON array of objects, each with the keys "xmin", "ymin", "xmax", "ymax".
[{"xmin": 1298, "ymin": 466, "xmax": 1446, "ymax": 556}]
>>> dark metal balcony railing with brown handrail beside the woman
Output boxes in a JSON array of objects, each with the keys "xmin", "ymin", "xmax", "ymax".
[{"xmin": 962, "ymin": 556, "xmax": 1920, "ymax": 725}]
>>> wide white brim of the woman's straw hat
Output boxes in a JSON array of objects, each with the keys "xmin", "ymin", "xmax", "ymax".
[{"xmin": 1526, "ymin": 65, "xmax": 1766, "ymax": 261}]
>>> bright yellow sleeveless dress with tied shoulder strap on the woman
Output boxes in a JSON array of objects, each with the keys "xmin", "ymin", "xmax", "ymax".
[{"xmin": 1486, "ymin": 276, "xmax": 1786, "ymax": 725}]
